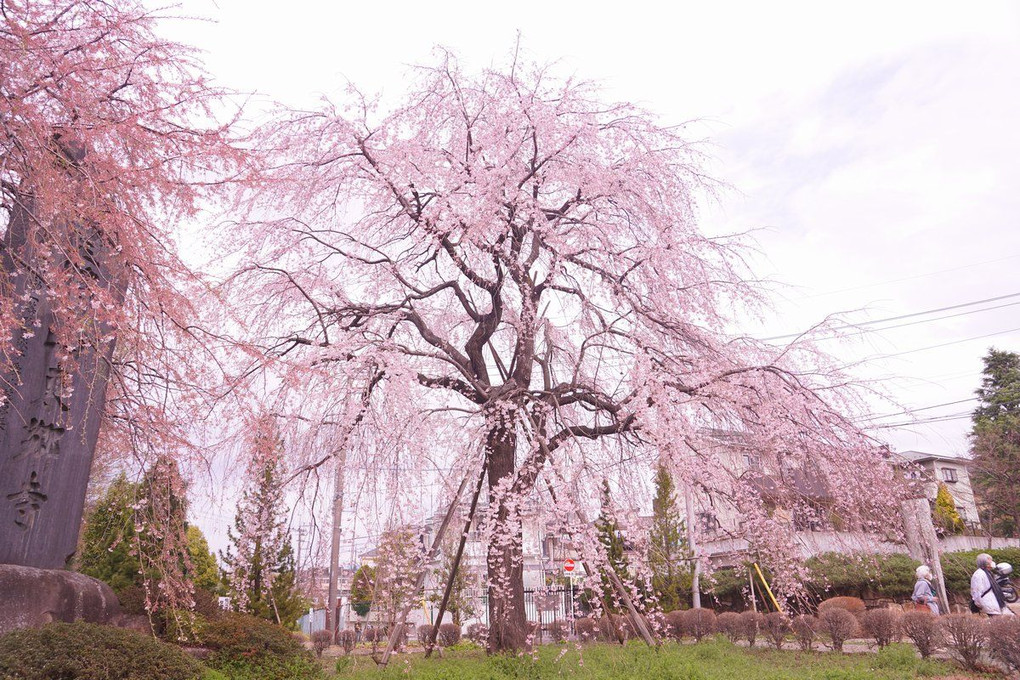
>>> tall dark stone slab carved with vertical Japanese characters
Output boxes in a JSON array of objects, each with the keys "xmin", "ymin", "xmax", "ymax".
[{"xmin": 0, "ymin": 192, "xmax": 122, "ymax": 569}]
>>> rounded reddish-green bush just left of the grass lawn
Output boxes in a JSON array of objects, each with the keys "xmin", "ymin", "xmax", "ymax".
[{"xmin": 199, "ymin": 613, "xmax": 322, "ymax": 680}]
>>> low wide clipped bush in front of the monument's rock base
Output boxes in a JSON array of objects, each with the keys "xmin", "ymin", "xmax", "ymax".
[{"xmin": 0, "ymin": 622, "xmax": 203, "ymax": 680}]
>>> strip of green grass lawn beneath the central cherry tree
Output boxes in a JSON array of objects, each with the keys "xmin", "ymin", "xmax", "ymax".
[{"xmin": 330, "ymin": 638, "xmax": 970, "ymax": 680}]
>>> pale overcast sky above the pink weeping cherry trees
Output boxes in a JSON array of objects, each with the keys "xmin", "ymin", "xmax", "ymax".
[{"xmin": 168, "ymin": 0, "xmax": 1020, "ymax": 554}]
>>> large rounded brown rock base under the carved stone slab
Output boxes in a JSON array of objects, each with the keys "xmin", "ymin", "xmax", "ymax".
[{"xmin": 0, "ymin": 565, "xmax": 121, "ymax": 634}]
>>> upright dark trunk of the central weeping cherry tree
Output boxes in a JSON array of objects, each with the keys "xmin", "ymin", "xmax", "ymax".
[{"xmin": 487, "ymin": 425, "xmax": 527, "ymax": 653}]
